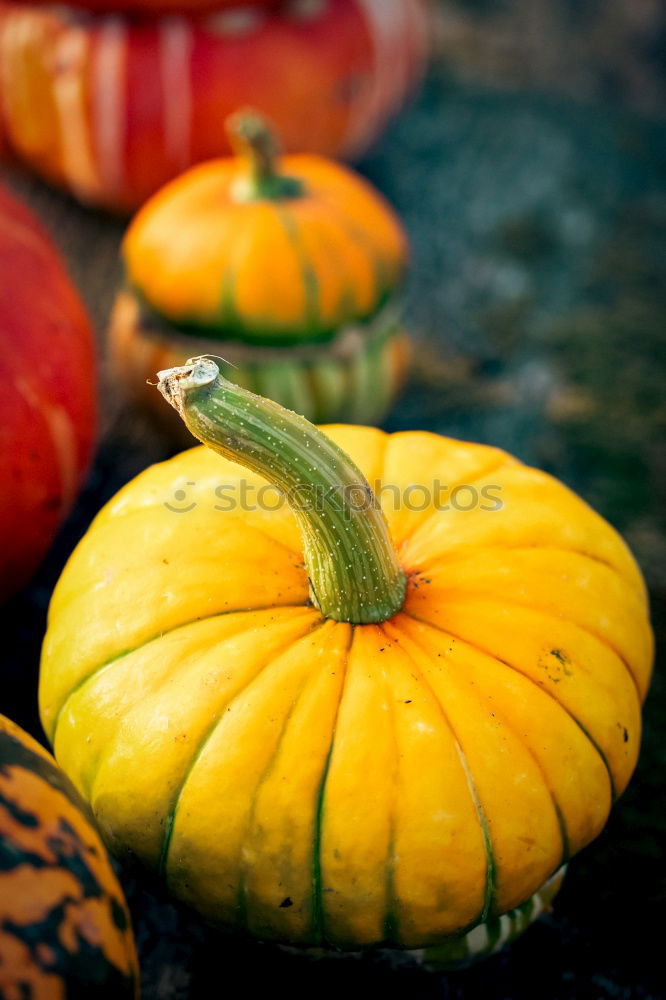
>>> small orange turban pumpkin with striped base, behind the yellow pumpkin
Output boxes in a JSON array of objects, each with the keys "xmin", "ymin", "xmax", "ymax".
[{"xmin": 110, "ymin": 112, "xmax": 407, "ymax": 434}]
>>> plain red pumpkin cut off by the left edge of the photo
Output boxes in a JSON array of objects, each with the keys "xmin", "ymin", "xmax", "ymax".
[{"xmin": 0, "ymin": 187, "xmax": 95, "ymax": 597}]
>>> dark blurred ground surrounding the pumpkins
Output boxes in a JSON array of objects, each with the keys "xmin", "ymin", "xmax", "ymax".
[{"xmin": 0, "ymin": 0, "xmax": 666, "ymax": 1000}]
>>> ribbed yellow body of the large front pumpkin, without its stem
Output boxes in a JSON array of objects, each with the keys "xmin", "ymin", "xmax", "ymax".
[{"xmin": 41, "ymin": 426, "xmax": 652, "ymax": 947}]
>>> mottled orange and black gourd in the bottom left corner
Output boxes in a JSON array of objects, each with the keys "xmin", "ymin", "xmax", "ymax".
[{"xmin": 0, "ymin": 716, "xmax": 138, "ymax": 1000}]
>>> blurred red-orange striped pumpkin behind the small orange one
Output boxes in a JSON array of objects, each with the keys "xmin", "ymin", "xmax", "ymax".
[{"xmin": 0, "ymin": 0, "xmax": 427, "ymax": 211}]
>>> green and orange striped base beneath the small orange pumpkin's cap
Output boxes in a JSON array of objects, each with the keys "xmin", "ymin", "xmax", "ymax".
[{"xmin": 109, "ymin": 291, "xmax": 409, "ymax": 437}]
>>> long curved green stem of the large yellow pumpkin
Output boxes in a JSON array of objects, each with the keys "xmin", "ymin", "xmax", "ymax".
[{"xmin": 158, "ymin": 358, "xmax": 406, "ymax": 625}]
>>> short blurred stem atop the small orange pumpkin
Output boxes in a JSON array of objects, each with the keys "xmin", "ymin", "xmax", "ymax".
[{"xmin": 227, "ymin": 110, "xmax": 303, "ymax": 201}]
